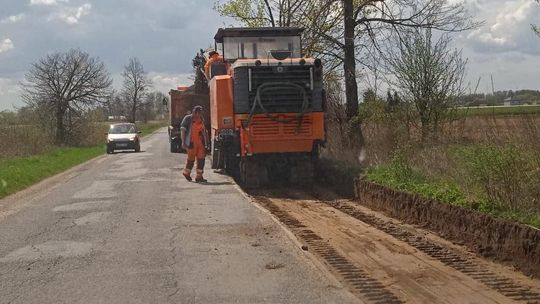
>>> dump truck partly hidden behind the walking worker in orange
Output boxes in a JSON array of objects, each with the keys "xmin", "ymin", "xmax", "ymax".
[{"xmin": 168, "ymin": 87, "xmax": 210, "ymax": 153}]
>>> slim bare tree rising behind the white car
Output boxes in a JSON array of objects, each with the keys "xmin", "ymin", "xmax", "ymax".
[{"xmin": 122, "ymin": 57, "xmax": 152, "ymax": 122}]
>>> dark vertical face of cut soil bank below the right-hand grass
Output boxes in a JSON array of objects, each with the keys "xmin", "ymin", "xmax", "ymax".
[{"xmin": 356, "ymin": 180, "xmax": 540, "ymax": 278}]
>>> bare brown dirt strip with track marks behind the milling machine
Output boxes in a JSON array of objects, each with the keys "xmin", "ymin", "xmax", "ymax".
[{"xmin": 249, "ymin": 190, "xmax": 540, "ymax": 303}]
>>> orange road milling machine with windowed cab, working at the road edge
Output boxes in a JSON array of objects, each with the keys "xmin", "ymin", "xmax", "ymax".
[{"xmin": 208, "ymin": 28, "xmax": 325, "ymax": 188}]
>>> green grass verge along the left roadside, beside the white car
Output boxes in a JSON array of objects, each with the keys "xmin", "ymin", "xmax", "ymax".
[{"xmin": 0, "ymin": 122, "xmax": 165, "ymax": 199}]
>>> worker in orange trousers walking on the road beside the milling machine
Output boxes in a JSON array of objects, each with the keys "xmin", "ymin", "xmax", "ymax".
[{"xmin": 180, "ymin": 106, "xmax": 208, "ymax": 183}]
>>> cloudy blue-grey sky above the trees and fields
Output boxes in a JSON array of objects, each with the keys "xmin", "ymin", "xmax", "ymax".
[{"xmin": 0, "ymin": 0, "xmax": 540, "ymax": 111}]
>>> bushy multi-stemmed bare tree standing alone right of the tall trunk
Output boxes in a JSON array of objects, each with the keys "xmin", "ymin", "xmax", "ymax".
[{"xmin": 387, "ymin": 29, "xmax": 467, "ymax": 138}]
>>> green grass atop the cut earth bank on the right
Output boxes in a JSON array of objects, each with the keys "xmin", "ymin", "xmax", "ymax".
[{"xmin": 366, "ymin": 162, "xmax": 540, "ymax": 229}]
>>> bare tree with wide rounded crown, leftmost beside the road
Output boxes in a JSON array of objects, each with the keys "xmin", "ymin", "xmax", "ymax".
[{"xmin": 21, "ymin": 49, "xmax": 112, "ymax": 144}]
